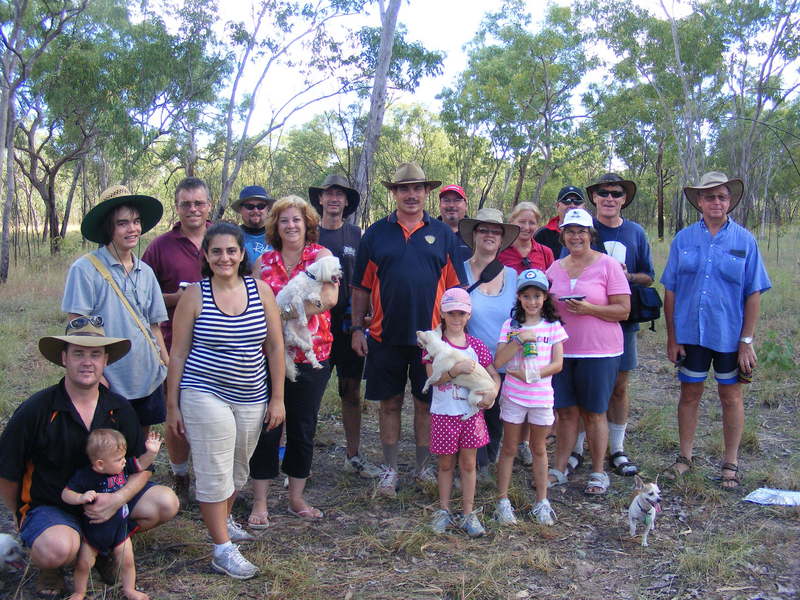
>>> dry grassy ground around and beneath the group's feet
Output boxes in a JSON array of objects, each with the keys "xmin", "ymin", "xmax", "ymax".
[{"xmin": 0, "ymin": 230, "xmax": 800, "ymax": 600}]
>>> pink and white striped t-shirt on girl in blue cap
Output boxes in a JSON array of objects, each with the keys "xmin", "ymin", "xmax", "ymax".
[{"xmin": 498, "ymin": 319, "xmax": 567, "ymax": 408}]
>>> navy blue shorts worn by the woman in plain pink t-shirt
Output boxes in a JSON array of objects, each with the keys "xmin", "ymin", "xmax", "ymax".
[{"xmin": 552, "ymin": 356, "xmax": 622, "ymax": 414}]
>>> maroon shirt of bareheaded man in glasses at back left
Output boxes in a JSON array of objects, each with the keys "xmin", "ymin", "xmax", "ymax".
[{"xmin": 142, "ymin": 222, "xmax": 211, "ymax": 350}]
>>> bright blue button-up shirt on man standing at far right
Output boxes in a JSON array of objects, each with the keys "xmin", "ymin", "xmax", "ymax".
[{"xmin": 661, "ymin": 217, "xmax": 772, "ymax": 352}]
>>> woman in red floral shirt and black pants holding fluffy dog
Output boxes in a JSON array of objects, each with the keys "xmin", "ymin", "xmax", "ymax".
[{"xmin": 248, "ymin": 196, "xmax": 339, "ymax": 529}]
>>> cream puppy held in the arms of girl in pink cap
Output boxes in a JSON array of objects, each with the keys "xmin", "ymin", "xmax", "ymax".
[{"xmin": 417, "ymin": 330, "xmax": 497, "ymax": 421}]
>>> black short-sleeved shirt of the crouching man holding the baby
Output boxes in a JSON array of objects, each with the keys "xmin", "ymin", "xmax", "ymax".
[{"xmin": 0, "ymin": 379, "xmax": 145, "ymax": 523}]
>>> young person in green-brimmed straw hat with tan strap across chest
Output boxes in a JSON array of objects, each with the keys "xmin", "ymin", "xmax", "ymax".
[{"xmin": 61, "ymin": 185, "xmax": 168, "ymax": 430}]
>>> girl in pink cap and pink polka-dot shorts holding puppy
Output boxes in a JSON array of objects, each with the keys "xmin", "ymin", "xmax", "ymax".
[{"xmin": 422, "ymin": 288, "xmax": 500, "ymax": 537}]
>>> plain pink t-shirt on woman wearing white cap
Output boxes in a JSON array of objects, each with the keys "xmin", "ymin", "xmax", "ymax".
[{"xmin": 547, "ymin": 254, "xmax": 631, "ymax": 358}]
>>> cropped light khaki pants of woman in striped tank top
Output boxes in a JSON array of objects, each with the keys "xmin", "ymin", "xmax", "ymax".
[{"xmin": 180, "ymin": 388, "xmax": 267, "ymax": 502}]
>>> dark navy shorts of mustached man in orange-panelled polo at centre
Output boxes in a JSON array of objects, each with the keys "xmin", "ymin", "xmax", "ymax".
[{"xmin": 364, "ymin": 338, "xmax": 431, "ymax": 404}]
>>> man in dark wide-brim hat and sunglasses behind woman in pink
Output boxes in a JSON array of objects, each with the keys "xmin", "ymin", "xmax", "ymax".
[{"xmin": 575, "ymin": 173, "xmax": 655, "ymax": 476}]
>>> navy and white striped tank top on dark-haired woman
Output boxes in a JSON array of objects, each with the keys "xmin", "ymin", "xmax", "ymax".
[{"xmin": 181, "ymin": 276, "xmax": 268, "ymax": 404}]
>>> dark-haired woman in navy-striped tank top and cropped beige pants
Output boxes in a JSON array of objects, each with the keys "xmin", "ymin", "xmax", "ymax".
[{"xmin": 167, "ymin": 223, "xmax": 285, "ymax": 579}]
